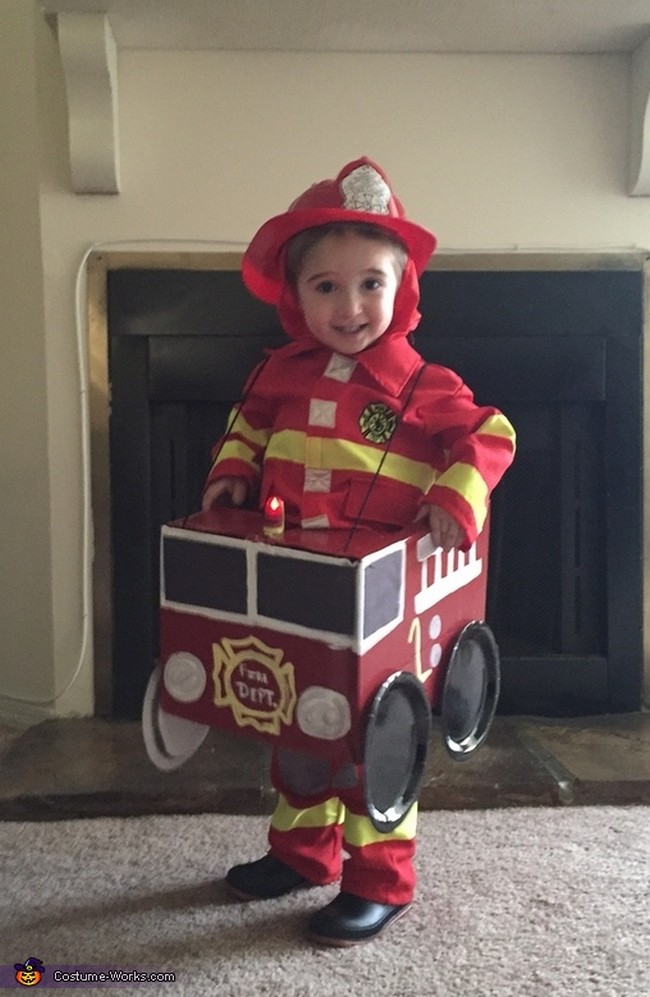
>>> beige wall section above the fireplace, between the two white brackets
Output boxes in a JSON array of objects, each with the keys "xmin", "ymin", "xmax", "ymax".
[{"xmin": 115, "ymin": 52, "xmax": 650, "ymax": 249}]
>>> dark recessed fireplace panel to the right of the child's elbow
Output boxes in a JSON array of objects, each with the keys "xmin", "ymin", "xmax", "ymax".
[{"xmin": 488, "ymin": 396, "xmax": 607, "ymax": 659}]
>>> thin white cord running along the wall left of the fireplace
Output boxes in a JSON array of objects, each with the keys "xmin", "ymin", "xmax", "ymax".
[{"xmin": 0, "ymin": 239, "xmax": 247, "ymax": 706}]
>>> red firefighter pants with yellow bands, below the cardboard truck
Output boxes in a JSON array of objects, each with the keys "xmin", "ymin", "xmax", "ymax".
[{"xmin": 269, "ymin": 752, "xmax": 417, "ymax": 904}]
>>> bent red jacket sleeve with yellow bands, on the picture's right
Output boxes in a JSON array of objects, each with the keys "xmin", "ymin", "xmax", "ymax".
[{"xmin": 422, "ymin": 368, "xmax": 516, "ymax": 550}]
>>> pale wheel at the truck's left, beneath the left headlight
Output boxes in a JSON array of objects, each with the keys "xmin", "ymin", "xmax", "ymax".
[{"xmin": 142, "ymin": 665, "xmax": 210, "ymax": 772}]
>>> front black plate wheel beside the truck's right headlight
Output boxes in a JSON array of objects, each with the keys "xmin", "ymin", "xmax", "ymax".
[{"xmin": 364, "ymin": 672, "xmax": 431, "ymax": 833}]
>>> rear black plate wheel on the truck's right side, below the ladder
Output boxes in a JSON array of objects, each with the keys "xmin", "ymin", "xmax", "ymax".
[{"xmin": 440, "ymin": 621, "xmax": 501, "ymax": 760}]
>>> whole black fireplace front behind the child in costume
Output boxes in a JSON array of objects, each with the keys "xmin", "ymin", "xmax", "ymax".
[{"xmin": 91, "ymin": 254, "xmax": 644, "ymax": 718}]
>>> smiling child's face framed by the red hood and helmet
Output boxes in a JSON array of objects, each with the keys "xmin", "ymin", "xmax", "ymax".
[{"xmin": 297, "ymin": 232, "xmax": 402, "ymax": 355}]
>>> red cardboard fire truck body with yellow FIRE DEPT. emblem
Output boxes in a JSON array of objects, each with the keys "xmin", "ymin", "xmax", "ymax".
[{"xmin": 154, "ymin": 509, "xmax": 488, "ymax": 767}]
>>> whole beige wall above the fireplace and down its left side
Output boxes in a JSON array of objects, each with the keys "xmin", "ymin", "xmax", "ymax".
[{"xmin": 0, "ymin": 0, "xmax": 650, "ymax": 719}]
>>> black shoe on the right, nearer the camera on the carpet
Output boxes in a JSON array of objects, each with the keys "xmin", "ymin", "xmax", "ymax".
[{"xmin": 309, "ymin": 893, "xmax": 411, "ymax": 946}]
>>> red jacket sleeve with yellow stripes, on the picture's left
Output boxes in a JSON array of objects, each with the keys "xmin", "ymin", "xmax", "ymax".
[{"xmin": 204, "ymin": 361, "xmax": 273, "ymax": 496}]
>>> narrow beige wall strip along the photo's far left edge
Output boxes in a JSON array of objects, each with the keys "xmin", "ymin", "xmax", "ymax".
[{"xmin": 0, "ymin": 0, "xmax": 54, "ymax": 720}]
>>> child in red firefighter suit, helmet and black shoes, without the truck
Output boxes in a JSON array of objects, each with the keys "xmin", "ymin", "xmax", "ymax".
[{"xmin": 203, "ymin": 158, "xmax": 514, "ymax": 946}]
